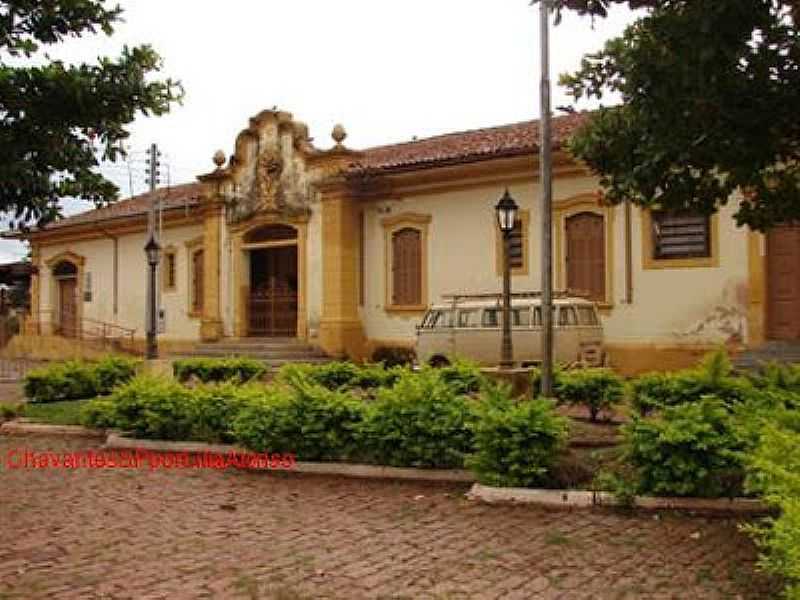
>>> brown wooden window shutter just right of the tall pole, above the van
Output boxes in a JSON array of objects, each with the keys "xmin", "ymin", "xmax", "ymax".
[{"xmin": 566, "ymin": 212, "xmax": 606, "ymax": 301}]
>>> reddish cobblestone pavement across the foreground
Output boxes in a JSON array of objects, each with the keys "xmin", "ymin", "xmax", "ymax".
[{"xmin": 0, "ymin": 436, "xmax": 775, "ymax": 600}]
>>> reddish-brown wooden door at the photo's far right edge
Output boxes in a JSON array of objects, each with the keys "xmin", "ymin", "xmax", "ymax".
[{"xmin": 767, "ymin": 224, "xmax": 800, "ymax": 341}]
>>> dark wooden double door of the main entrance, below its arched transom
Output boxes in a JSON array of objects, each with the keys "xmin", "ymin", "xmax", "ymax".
[{"xmin": 248, "ymin": 245, "xmax": 298, "ymax": 337}]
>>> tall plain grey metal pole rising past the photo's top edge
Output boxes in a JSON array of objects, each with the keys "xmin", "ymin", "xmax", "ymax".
[{"xmin": 539, "ymin": 0, "xmax": 553, "ymax": 398}]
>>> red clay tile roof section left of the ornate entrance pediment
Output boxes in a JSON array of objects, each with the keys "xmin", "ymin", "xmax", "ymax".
[{"xmin": 44, "ymin": 183, "xmax": 202, "ymax": 230}]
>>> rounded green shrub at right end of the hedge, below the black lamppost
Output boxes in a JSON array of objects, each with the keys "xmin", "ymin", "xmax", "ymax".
[{"xmin": 467, "ymin": 387, "xmax": 567, "ymax": 487}]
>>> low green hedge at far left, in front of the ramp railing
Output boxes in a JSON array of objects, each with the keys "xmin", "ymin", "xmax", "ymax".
[{"xmin": 23, "ymin": 356, "xmax": 139, "ymax": 403}]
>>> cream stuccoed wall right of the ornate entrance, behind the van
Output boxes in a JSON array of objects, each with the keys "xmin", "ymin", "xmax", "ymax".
[{"xmin": 361, "ymin": 177, "xmax": 748, "ymax": 344}]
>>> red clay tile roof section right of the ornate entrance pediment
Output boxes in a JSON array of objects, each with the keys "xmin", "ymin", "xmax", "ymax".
[{"xmin": 351, "ymin": 113, "xmax": 588, "ymax": 172}]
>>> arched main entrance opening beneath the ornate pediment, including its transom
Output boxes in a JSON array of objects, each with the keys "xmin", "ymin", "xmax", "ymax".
[{"xmin": 244, "ymin": 225, "xmax": 299, "ymax": 337}]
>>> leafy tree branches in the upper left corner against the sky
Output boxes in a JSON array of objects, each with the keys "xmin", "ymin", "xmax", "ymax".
[{"xmin": 0, "ymin": 0, "xmax": 183, "ymax": 226}]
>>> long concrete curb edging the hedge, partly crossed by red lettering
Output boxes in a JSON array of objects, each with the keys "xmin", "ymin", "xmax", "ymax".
[{"xmin": 104, "ymin": 432, "xmax": 475, "ymax": 483}]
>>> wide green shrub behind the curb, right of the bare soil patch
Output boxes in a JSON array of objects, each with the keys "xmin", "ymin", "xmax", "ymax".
[{"xmin": 622, "ymin": 396, "xmax": 746, "ymax": 498}]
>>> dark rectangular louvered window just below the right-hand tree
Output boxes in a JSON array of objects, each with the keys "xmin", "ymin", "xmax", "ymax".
[{"xmin": 652, "ymin": 212, "xmax": 711, "ymax": 259}]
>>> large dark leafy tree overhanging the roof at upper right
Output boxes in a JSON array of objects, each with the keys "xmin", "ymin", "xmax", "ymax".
[{"xmin": 552, "ymin": 0, "xmax": 800, "ymax": 230}]
